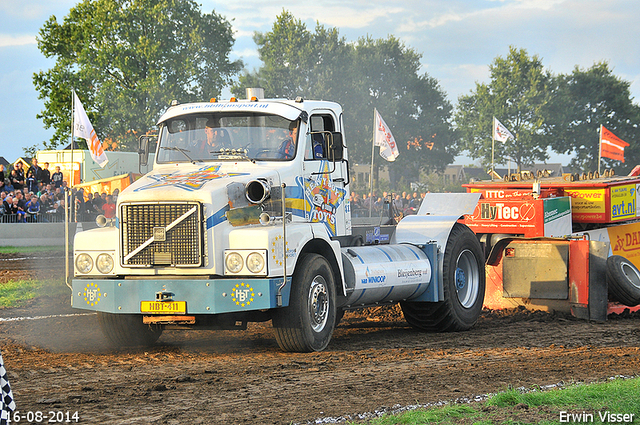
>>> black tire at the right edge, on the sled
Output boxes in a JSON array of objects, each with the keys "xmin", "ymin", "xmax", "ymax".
[{"xmin": 607, "ymin": 255, "xmax": 640, "ymax": 307}]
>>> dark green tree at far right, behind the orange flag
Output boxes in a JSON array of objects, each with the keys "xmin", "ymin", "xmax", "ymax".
[{"xmin": 547, "ymin": 62, "xmax": 640, "ymax": 171}]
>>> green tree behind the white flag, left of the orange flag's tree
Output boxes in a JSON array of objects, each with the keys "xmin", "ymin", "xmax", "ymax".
[{"xmin": 455, "ymin": 46, "xmax": 552, "ymax": 168}]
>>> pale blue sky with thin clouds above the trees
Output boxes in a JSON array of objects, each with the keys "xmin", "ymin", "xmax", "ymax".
[{"xmin": 0, "ymin": 0, "xmax": 640, "ymax": 164}]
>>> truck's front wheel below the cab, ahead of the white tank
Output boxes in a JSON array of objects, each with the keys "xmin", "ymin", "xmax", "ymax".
[{"xmin": 272, "ymin": 254, "xmax": 336, "ymax": 353}]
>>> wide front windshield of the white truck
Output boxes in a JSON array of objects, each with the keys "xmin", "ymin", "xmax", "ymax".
[{"xmin": 157, "ymin": 112, "xmax": 299, "ymax": 162}]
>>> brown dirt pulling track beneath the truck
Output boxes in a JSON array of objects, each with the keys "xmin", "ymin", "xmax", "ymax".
[{"xmin": 0, "ymin": 253, "xmax": 640, "ymax": 424}]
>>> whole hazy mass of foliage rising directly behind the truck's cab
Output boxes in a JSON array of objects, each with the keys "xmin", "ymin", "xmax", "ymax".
[{"xmin": 234, "ymin": 11, "xmax": 457, "ymax": 187}]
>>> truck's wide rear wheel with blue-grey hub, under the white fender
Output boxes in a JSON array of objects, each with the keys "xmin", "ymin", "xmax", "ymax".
[{"xmin": 400, "ymin": 223, "xmax": 485, "ymax": 332}]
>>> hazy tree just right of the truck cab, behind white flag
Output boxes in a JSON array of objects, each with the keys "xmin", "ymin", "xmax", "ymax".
[{"xmin": 345, "ymin": 36, "xmax": 457, "ymax": 184}]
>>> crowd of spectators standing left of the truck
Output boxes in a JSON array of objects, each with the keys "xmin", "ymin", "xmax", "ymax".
[{"xmin": 0, "ymin": 158, "xmax": 117, "ymax": 223}]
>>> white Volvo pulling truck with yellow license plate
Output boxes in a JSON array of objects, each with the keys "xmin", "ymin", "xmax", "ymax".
[{"xmin": 72, "ymin": 97, "xmax": 485, "ymax": 352}]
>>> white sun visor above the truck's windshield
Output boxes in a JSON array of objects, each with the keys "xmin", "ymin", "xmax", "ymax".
[{"xmin": 158, "ymin": 101, "xmax": 304, "ymax": 124}]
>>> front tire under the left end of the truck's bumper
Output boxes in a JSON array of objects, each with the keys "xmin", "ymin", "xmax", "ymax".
[{"xmin": 98, "ymin": 312, "xmax": 163, "ymax": 347}]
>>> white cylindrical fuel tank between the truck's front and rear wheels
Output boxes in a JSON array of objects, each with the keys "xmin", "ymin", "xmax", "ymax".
[{"xmin": 342, "ymin": 244, "xmax": 432, "ymax": 307}]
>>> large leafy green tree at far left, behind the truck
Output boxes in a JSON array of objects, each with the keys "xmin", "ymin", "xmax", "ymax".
[{"xmin": 33, "ymin": 0, "xmax": 242, "ymax": 149}]
